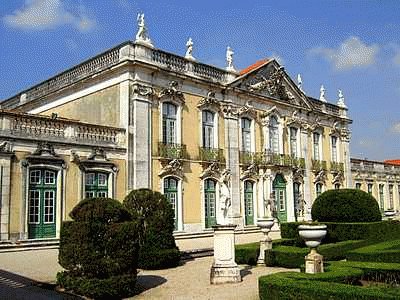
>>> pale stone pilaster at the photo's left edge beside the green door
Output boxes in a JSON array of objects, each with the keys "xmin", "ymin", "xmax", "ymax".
[{"xmin": 0, "ymin": 156, "xmax": 11, "ymax": 241}]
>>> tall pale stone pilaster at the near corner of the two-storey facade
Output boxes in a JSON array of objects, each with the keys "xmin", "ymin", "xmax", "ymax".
[{"xmin": 128, "ymin": 84, "xmax": 153, "ymax": 190}]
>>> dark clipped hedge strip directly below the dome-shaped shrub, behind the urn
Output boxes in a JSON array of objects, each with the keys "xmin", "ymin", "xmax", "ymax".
[{"xmin": 281, "ymin": 220, "xmax": 400, "ymax": 246}]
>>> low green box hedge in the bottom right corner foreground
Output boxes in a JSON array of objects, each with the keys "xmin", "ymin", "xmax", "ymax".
[{"xmin": 259, "ymin": 262, "xmax": 400, "ymax": 300}]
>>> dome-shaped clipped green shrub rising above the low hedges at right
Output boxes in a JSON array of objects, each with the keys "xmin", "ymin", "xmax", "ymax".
[{"xmin": 311, "ymin": 189, "xmax": 382, "ymax": 222}]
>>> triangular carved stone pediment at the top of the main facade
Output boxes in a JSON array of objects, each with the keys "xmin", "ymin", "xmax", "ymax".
[{"xmin": 234, "ymin": 61, "xmax": 312, "ymax": 109}]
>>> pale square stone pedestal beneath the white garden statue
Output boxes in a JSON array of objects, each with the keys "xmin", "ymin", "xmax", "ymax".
[{"xmin": 210, "ymin": 224, "xmax": 242, "ymax": 284}]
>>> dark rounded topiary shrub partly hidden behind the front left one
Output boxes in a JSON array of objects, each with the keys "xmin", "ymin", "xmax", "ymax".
[{"xmin": 123, "ymin": 189, "xmax": 180, "ymax": 269}]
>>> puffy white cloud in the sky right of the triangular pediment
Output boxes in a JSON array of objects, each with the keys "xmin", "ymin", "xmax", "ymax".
[{"xmin": 310, "ymin": 36, "xmax": 380, "ymax": 70}]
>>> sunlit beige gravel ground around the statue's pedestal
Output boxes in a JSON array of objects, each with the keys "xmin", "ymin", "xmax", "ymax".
[{"xmin": 130, "ymin": 257, "xmax": 299, "ymax": 300}]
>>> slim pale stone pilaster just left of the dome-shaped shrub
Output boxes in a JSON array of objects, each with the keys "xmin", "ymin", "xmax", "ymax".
[{"xmin": 300, "ymin": 128, "xmax": 312, "ymax": 221}]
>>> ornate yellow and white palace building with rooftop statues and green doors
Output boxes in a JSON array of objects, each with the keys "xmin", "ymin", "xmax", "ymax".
[{"xmin": 0, "ymin": 17, "xmax": 352, "ymax": 241}]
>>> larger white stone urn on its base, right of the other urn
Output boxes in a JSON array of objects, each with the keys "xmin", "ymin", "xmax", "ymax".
[{"xmin": 298, "ymin": 224, "xmax": 326, "ymax": 274}]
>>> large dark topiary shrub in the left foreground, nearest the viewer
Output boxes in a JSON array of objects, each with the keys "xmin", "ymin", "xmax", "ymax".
[{"xmin": 57, "ymin": 198, "xmax": 139, "ymax": 299}]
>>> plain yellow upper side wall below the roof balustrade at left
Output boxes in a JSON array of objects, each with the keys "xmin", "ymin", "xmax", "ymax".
[{"xmin": 42, "ymin": 84, "xmax": 120, "ymax": 127}]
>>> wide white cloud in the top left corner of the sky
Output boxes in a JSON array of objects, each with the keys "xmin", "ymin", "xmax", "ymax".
[{"xmin": 3, "ymin": 0, "xmax": 96, "ymax": 32}]
